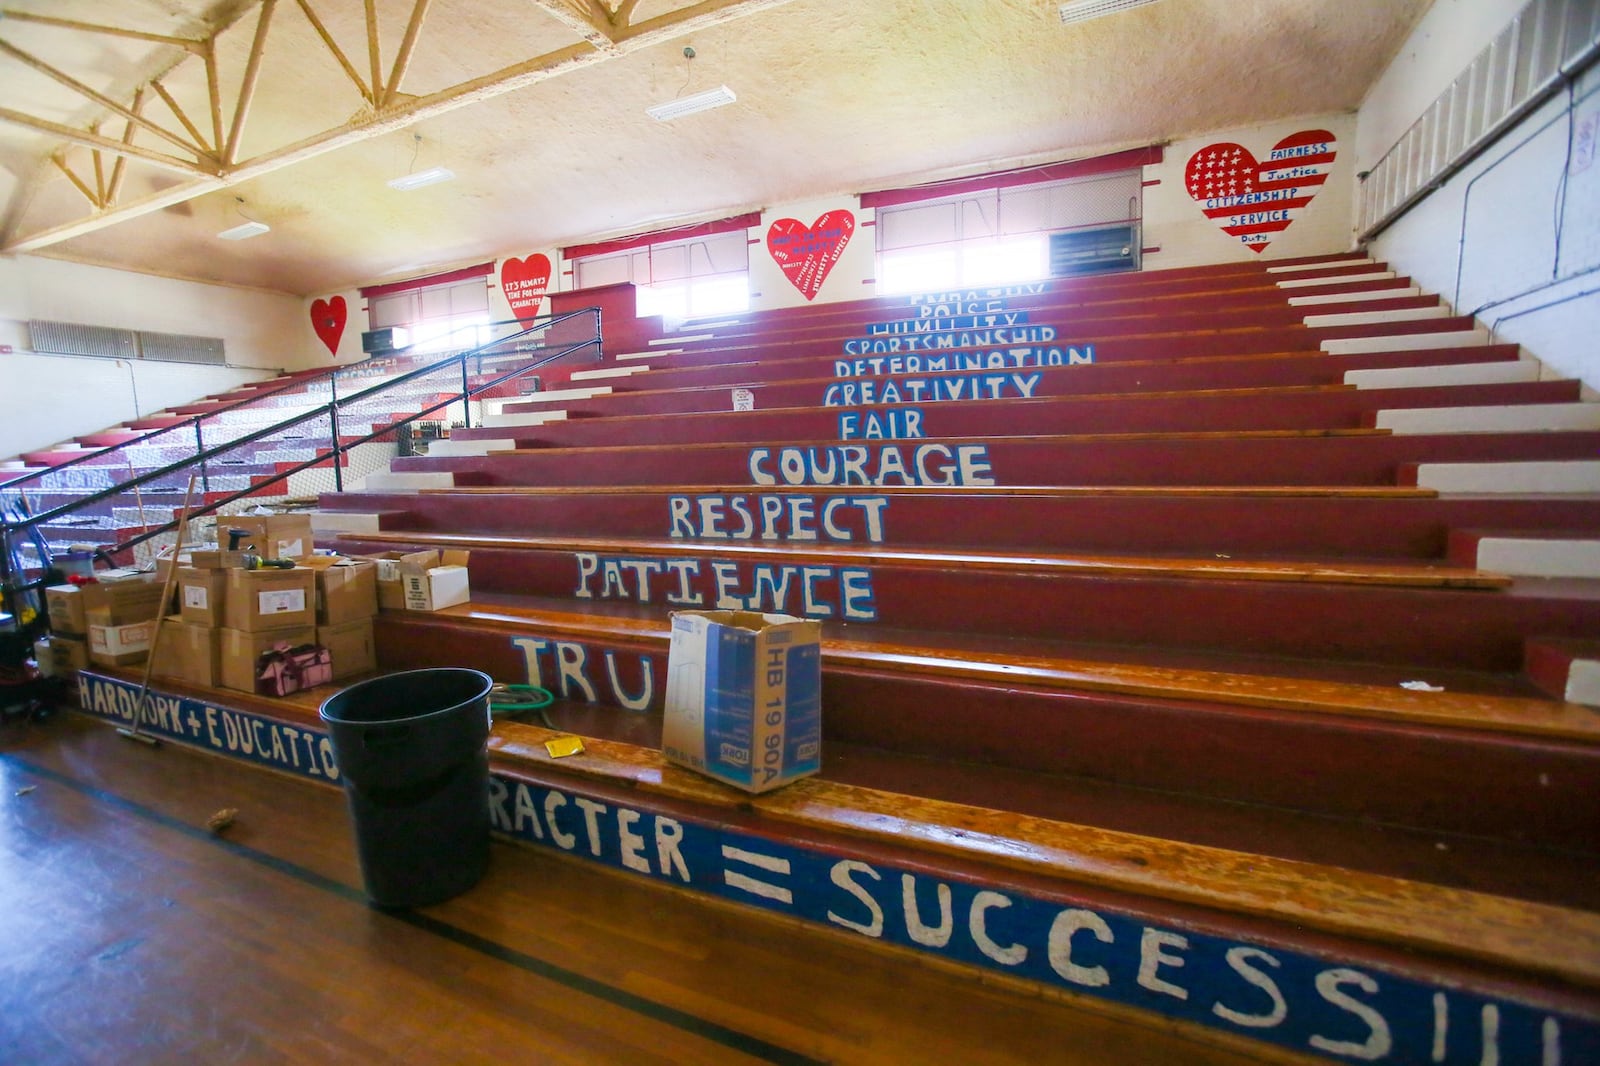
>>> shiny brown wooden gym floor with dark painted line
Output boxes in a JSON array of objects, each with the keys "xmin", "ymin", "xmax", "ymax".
[{"xmin": 0, "ymin": 714, "xmax": 1298, "ymax": 1066}]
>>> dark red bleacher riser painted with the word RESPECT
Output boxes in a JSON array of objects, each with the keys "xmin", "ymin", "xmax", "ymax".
[{"xmin": 334, "ymin": 485, "xmax": 1600, "ymax": 565}]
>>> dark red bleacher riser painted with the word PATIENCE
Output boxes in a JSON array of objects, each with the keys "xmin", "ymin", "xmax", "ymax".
[{"xmin": 331, "ymin": 538, "xmax": 1600, "ymax": 671}]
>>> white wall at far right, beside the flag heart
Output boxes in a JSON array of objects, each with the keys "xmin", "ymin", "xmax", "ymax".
[{"xmin": 1357, "ymin": 0, "xmax": 1600, "ymax": 387}]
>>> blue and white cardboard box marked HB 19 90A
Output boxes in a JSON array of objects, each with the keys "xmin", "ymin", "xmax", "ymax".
[{"xmin": 662, "ymin": 611, "xmax": 822, "ymax": 792}]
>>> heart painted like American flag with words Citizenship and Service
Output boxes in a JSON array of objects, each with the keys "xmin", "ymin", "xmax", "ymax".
[{"xmin": 1184, "ymin": 130, "xmax": 1336, "ymax": 253}]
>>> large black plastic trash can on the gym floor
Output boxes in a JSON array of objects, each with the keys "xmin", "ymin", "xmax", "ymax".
[{"xmin": 320, "ymin": 667, "xmax": 494, "ymax": 908}]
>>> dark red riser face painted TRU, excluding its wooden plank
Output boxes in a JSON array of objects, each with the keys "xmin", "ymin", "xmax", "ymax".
[{"xmin": 368, "ymin": 615, "xmax": 1600, "ymax": 847}]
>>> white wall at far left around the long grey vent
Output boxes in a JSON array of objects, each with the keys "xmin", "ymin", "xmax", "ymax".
[{"xmin": 0, "ymin": 256, "xmax": 315, "ymax": 458}]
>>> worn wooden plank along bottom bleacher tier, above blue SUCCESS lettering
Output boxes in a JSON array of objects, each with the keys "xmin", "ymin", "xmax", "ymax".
[{"xmin": 505, "ymin": 710, "xmax": 1600, "ymax": 984}]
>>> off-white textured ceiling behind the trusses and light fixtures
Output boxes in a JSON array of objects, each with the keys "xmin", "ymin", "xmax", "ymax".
[{"xmin": 0, "ymin": 0, "xmax": 1430, "ymax": 295}]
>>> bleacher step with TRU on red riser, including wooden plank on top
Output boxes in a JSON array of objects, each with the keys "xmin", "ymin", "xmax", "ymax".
[{"xmin": 378, "ymin": 592, "xmax": 1600, "ymax": 851}]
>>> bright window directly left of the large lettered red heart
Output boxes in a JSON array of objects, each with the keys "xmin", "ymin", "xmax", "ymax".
[{"xmin": 573, "ymin": 229, "xmax": 750, "ymax": 319}]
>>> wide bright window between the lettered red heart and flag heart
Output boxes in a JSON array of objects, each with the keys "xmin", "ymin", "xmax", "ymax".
[{"xmin": 875, "ymin": 170, "xmax": 1142, "ymax": 295}]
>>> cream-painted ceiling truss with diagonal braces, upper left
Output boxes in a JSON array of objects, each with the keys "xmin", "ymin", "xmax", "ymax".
[{"xmin": 0, "ymin": 0, "xmax": 789, "ymax": 253}]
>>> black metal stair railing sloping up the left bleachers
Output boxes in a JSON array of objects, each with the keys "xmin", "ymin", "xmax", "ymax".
[{"xmin": 0, "ymin": 307, "xmax": 603, "ymax": 621}]
